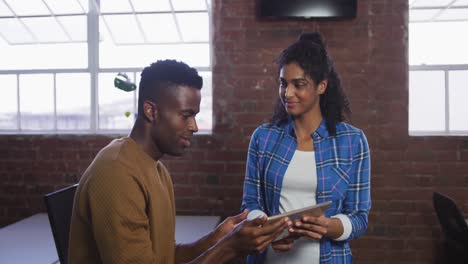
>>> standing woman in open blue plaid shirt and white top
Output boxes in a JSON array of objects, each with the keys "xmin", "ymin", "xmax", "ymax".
[{"xmin": 242, "ymin": 33, "xmax": 371, "ymax": 263}]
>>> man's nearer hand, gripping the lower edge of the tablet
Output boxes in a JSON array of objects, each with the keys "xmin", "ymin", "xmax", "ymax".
[{"xmin": 225, "ymin": 216, "xmax": 292, "ymax": 255}]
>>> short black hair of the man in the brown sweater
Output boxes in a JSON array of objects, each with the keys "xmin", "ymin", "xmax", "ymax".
[{"xmin": 138, "ymin": 60, "xmax": 203, "ymax": 115}]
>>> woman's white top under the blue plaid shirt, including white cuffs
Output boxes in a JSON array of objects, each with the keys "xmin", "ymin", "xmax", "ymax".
[{"xmin": 264, "ymin": 150, "xmax": 352, "ymax": 263}]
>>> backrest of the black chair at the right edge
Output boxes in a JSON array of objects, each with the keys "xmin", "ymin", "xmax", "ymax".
[{"xmin": 432, "ymin": 192, "xmax": 468, "ymax": 246}]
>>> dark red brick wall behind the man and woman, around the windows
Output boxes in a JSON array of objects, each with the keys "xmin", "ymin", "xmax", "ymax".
[{"xmin": 0, "ymin": 0, "xmax": 468, "ymax": 264}]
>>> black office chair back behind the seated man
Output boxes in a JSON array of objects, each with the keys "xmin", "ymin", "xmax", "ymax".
[{"xmin": 44, "ymin": 184, "xmax": 78, "ymax": 264}]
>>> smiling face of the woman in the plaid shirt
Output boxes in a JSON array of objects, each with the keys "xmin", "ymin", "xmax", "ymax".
[{"xmin": 279, "ymin": 63, "xmax": 327, "ymax": 117}]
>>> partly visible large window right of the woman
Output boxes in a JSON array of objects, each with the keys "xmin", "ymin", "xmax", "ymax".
[{"xmin": 409, "ymin": 0, "xmax": 468, "ymax": 135}]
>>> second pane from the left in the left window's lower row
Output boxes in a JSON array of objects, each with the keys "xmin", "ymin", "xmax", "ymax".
[{"xmin": 19, "ymin": 74, "xmax": 54, "ymax": 130}]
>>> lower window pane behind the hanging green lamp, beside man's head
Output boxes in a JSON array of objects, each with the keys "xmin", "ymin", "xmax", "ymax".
[{"xmin": 99, "ymin": 73, "xmax": 135, "ymax": 129}]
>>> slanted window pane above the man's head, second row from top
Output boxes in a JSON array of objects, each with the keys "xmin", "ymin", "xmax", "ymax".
[{"xmin": 138, "ymin": 14, "xmax": 181, "ymax": 43}]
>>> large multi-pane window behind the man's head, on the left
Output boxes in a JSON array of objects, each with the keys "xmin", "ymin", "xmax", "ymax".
[{"xmin": 0, "ymin": 0, "xmax": 212, "ymax": 134}]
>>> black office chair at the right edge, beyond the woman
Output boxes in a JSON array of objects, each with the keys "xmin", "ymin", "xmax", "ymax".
[{"xmin": 432, "ymin": 192, "xmax": 468, "ymax": 264}]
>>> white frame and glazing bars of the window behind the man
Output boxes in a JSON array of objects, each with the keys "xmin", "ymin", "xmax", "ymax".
[{"xmin": 0, "ymin": 0, "xmax": 213, "ymax": 135}]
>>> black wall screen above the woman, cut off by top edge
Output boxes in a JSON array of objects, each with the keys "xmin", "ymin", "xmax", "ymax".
[{"xmin": 258, "ymin": 0, "xmax": 357, "ymax": 19}]
